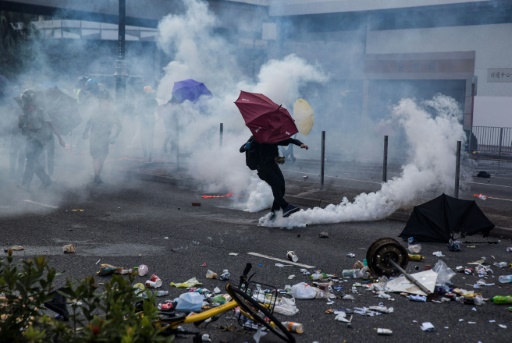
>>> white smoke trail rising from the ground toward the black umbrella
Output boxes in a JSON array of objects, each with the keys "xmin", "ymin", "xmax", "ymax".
[{"xmin": 260, "ymin": 95, "xmax": 465, "ymax": 227}]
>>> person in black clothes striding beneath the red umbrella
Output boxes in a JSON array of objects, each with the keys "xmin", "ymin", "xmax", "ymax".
[{"xmin": 240, "ymin": 136, "xmax": 309, "ymax": 220}]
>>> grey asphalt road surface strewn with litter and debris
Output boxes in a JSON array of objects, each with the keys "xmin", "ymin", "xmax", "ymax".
[{"xmin": 0, "ymin": 170, "xmax": 512, "ymax": 342}]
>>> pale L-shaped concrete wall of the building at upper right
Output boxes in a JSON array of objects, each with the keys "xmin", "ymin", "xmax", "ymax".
[{"xmin": 366, "ymin": 24, "xmax": 512, "ymax": 127}]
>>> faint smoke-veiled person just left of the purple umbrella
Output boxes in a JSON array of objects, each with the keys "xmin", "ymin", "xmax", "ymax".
[{"xmin": 139, "ymin": 86, "xmax": 158, "ymax": 162}]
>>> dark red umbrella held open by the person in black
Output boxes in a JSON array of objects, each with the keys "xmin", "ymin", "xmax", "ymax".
[{"xmin": 235, "ymin": 91, "xmax": 299, "ymax": 143}]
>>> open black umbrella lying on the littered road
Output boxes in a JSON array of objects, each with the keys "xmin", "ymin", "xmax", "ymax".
[{"xmin": 399, "ymin": 194, "xmax": 494, "ymax": 243}]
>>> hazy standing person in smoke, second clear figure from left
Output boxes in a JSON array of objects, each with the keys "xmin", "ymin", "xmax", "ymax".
[{"xmin": 82, "ymin": 89, "xmax": 122, "ymax": 184}]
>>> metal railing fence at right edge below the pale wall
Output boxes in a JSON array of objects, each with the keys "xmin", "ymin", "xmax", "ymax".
[{"xmin": 467, "ymin": 126, "xmax": 512, "ymax": 156}]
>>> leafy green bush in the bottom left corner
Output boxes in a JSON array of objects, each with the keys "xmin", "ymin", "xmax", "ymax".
[{"xmin": 0, "ymin": 251, "xmax": 173, "ymax": 343}]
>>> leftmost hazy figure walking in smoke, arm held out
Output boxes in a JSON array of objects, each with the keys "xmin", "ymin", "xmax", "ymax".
[{"xmin": 18, "ymin": 89, "xmax": 65, "ymax": 190}]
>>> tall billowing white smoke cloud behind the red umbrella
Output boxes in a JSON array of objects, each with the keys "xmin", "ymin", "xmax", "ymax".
[{"xmin": 157, "ymin": 1, "xmax": 327, "ymax": 202}]
